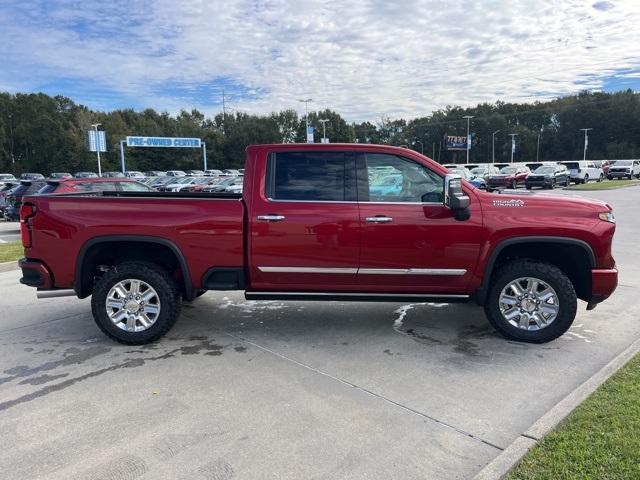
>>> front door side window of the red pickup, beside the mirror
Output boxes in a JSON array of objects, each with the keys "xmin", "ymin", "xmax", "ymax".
[{"xmin": 361, "ymin": 153, "xmax": 444, "ymax": 203}]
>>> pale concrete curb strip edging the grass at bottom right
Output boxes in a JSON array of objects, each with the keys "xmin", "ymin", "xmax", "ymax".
[{"xmin": 473, "ymin": 338, "xmax": 640, "ymax": 480}]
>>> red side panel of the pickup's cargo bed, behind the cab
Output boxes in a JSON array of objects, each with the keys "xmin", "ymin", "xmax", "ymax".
[{"xmin": 25, "ymin": 192, "xmax": 244, "ymax": 289}]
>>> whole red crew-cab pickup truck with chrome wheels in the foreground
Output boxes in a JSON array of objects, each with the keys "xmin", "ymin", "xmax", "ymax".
[{"xmin": 20, "ymin": 144, "xmax": 618, "ymax": 344}]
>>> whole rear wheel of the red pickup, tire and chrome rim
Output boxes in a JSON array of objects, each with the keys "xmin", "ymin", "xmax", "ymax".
[{"xmin": 91, "ymin": 262, "xmax": 181, "ymax": 345}]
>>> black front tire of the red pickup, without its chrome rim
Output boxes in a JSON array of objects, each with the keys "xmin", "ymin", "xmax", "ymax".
[{"xmin": 484, "ymin": 259, "xmax": 578, "ymax": 343}]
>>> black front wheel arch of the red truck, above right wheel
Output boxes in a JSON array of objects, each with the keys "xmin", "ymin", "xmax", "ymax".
[{"xmin": 475, "ymin": 236, "xmax": 596, "ymax": 305}]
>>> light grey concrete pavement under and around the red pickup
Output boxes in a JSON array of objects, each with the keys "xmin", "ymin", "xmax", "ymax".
[{"xmin": 0, "ymin": 187, "xmax": 640, "ymax": 480}]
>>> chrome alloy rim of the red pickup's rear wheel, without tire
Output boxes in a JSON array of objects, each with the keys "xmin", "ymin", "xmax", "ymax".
[{"xmin": 106, "ymin": 278, "xmax": 160, "ymax": 332}]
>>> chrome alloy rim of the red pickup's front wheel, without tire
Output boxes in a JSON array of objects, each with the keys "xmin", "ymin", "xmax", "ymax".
[{"xmin": 499, "ymin": 277, "xmax": 560, "ymax": 330}]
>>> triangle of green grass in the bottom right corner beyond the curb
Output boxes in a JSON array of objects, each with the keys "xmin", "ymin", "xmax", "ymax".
[{"xmin": 507, "ymin": 355, "xmax": 640, "ymax": 480}]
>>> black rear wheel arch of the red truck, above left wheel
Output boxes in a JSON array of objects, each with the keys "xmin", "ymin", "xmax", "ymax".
[{"xmin": 74, "ymin": 235, "xmax": 194, "ymax": 300}]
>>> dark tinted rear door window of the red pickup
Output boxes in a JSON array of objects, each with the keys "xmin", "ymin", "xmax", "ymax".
[{"xmin": 266, "ymin": 152, "xmax": 350, "ymax": 202}]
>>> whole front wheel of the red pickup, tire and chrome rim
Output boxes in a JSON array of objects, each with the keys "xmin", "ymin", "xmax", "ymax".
[{"xmin": 484, "ymin": 260, "xmax": 578, "ymax": 343}]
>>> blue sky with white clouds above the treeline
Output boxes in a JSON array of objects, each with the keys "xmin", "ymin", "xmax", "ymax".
[{"xmin": 0, "ymin": 0, "xmax": 640, "ymax": 121}]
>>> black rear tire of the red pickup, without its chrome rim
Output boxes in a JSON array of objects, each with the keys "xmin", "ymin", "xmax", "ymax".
[{"xmin": 91, "ymin": 262, "xmax": 182, "ymax": 345}]
